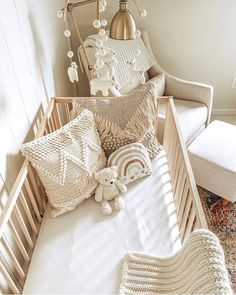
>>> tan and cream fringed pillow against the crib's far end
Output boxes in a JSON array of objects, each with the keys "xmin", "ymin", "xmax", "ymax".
[{"xmin": 71, "ymin": 75, "xmax": 164, "ymax": 158}]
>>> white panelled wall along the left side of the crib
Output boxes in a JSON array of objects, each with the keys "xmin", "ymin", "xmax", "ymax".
[{"xmin": 0, "ymin": 0, "xmax": 74, "ymax": 207}]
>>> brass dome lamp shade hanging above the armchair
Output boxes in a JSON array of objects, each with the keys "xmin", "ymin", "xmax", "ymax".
[{"xmin": 110, "ymin": 0, "xmax": 136, "ymax": 40}]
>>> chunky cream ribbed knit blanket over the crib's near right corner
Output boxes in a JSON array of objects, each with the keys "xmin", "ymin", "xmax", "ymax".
[{"xmin": 120, "ymin": 230, "xmax": 233, "ymax": 295}]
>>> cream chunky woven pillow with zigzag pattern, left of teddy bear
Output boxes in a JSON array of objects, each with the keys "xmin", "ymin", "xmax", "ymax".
[{"xmin": 21, "ymin": 110, "xmax": 106, "ymax": 217}]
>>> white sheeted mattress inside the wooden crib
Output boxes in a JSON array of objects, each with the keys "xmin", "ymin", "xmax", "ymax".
[{"xmin": 24, "ymin": 152, "xmax": 180, "ymax": 294}]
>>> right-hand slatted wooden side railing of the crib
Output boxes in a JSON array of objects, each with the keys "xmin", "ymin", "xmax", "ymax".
[{"xmin": 163, "ymin": 98, "xmax": 207, "ymax": 242}]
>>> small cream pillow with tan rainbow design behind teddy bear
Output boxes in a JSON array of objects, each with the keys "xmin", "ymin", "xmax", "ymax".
[{"xmin": 107, "ymin": 143, "xmax": 152, "ymax": 184}]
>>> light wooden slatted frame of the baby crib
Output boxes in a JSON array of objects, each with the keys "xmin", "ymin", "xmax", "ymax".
[{"xmin": 0, "ymin": 97, "xmax": 207, "ymax": 294}]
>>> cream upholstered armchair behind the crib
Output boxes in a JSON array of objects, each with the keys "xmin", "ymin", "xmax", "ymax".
[{"xmin": 78, "ymin": 31, "xmax": 213, "ymax": 146}]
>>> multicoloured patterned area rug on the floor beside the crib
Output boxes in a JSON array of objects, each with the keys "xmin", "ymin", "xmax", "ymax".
[{"xmin": 198, "ymin": 187, "xmax": 236, "ymax": 292}]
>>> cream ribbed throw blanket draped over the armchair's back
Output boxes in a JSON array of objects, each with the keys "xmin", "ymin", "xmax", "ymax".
[{"xmin": 84, "ymin": 35, "xmax": 155, "ymax": 88}]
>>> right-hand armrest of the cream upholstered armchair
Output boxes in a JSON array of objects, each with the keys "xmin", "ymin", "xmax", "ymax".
[{"xmin": 164, "ymin": 73, "xmax": 213, "ymax": 125}]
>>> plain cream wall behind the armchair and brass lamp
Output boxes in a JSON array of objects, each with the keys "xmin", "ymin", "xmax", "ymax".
[{"xmin": 74, "ymin": 0, "xmax": 236, "ymax": 114}]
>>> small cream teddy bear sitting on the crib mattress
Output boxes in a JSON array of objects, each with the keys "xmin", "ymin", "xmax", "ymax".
[{"xmin": 94, "ymin": 166, "xmax": 127, "ymax": 215}]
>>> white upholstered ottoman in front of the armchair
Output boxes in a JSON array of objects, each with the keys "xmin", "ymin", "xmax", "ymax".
[{"xmin": 188, "ymin": 121, "xmax": 236, "ymax": 202}]
